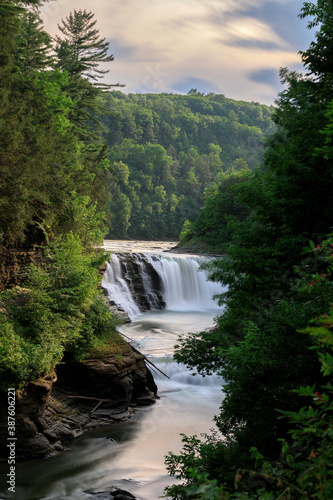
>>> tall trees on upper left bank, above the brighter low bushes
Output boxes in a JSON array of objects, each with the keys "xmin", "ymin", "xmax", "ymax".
[{"xmin": 0, "ymin": 1, "xmax": 111, "ymax": 248}]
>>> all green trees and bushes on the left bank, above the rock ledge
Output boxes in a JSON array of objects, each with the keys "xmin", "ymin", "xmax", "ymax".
[{"xmin": 0, "ymin": 0, "xmax": 126, "ymax": 390}]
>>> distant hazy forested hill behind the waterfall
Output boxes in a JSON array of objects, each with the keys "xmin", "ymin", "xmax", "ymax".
[{"xmin": 102, "ymin": 90, "xmax": 274, "ymax": 239}]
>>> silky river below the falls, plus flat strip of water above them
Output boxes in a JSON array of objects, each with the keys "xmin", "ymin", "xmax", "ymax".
[{"xmin": 0, "ymin": 242, "xmax": 223, "ymax": 500}]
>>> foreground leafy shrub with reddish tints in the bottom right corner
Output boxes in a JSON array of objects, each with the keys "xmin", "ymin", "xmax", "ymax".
[{"xmin": 238, "ymin": 315, "xmax": 333, "ymax": 500}]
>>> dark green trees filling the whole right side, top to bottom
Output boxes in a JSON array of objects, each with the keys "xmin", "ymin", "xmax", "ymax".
[{"xmin": 166, "ymin": 0, "xmax": 333, "ymax": 500}]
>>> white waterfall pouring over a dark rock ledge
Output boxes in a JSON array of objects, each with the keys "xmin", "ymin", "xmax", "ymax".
[{"xmin": 102, "ymin": 253, "xmax": 223, "ymax": 319}]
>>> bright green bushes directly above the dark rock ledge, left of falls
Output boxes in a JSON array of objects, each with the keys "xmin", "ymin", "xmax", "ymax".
[{"xmin": 0, "ymin": 234, "xmax": 118, "ymax": 390}]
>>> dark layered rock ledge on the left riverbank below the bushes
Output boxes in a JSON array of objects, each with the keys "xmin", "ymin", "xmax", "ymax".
[{"xmin": 0, "ymin": 346, "xmax": 157, "ymax": 460}]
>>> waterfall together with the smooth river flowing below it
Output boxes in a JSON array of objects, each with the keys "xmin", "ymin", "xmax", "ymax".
[{"xmin": 0, "ymin": 242, "xmax": 223, "ymax": 500}]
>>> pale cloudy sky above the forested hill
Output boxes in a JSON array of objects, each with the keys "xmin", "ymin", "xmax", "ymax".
[{"xmin": 42, "ymin": 0, "xmax": 315, "ymax": 105}]
